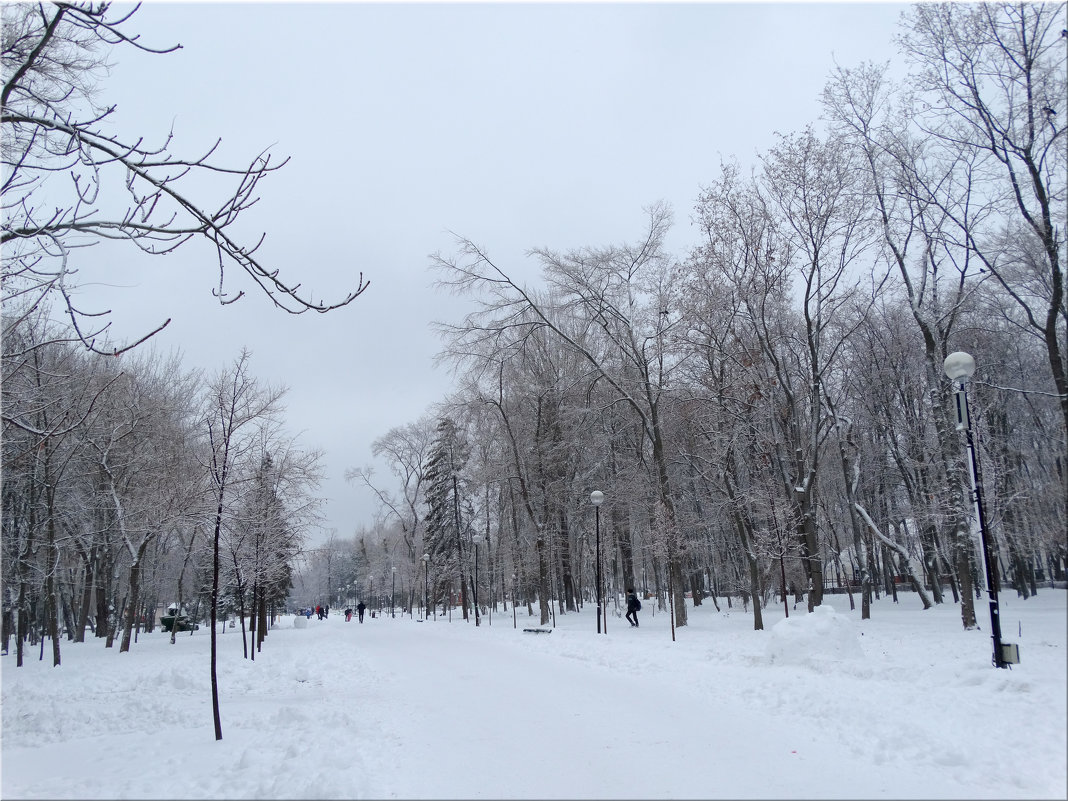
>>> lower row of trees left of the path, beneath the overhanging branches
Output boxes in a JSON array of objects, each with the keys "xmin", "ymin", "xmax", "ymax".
[{"xmin": 2, "ymin": 335, "xmax": 319, "ymax": 665}]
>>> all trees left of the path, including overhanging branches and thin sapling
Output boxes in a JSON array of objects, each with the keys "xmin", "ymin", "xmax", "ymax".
[{"xmin": 0, "ymin": 1, "xmax": 368, "ymax": 739}]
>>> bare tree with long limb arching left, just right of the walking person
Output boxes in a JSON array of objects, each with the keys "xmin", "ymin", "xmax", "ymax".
[{"xmin": 434, "ymin": 204, "xmax": 687, "ymax": 626}]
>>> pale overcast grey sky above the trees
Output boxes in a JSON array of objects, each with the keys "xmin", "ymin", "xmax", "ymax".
[{"xmin": 73, "ymin": 2, "xmax": 908, "ymax": 539}]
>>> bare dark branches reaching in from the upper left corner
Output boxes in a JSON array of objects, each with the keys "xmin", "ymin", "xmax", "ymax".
[{"xmin": 0, "ymin": 2, "xmax": 367, "ymax": 354}]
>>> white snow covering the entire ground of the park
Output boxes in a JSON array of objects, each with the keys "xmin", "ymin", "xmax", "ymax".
[{"xmin": 0, "ymin": 588, "xmax": 1068, "ymax": 799}]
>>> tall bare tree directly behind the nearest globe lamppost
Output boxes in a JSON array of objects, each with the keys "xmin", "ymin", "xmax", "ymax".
[{"xmin": 823, "ymin": 59, "xmax": 992, "ymax": 629}]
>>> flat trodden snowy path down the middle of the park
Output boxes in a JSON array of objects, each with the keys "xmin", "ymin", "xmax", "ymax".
[{"xmin": 346, "ymin": 624, "xmax": 803, "ymax": 798}]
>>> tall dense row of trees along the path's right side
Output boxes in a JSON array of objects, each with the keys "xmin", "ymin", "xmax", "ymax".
[{"xmin": 350, "ymin": 3, "xmax": 1068, "ymax": 628}]
